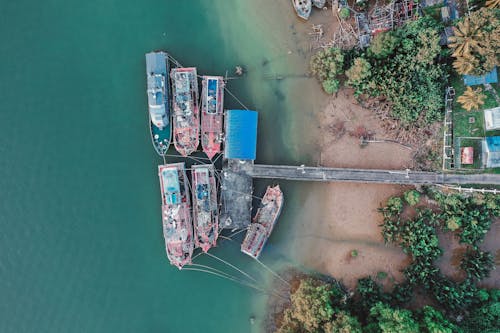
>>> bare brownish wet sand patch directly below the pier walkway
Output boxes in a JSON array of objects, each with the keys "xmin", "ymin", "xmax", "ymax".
[{"xmin": 293, "ymin": 183, "xmax": 408, "ymax": 288}]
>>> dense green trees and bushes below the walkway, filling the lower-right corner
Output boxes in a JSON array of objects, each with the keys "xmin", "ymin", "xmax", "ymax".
[{"xmin": 278, "ymin": 189, "xmax": 500, "ymax": 333}]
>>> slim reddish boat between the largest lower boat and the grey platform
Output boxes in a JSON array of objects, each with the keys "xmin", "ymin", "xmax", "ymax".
[{"xmin": 191, "ymin": 164, "xmax": 219, "ymax": 252}]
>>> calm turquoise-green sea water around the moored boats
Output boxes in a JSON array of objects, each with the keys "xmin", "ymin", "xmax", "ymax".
[{"xmin": 0, "ymin": 0, "xmax": 320, "ymax": 333}]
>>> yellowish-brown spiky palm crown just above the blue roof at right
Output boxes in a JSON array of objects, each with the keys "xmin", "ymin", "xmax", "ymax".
[{"xmin": 448, "ymin": 17, "xmax": 482, "ymax": 57}]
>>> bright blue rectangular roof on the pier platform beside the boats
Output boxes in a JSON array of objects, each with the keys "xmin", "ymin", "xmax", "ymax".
[{"xmin": 224, "ymin": 110, "xmax": 258, "ymax": 160}]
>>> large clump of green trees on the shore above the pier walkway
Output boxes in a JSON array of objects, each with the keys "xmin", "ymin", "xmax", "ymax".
[{"xmin": 311, "ymin": 18, "xmax": 446, "ymax": 125}]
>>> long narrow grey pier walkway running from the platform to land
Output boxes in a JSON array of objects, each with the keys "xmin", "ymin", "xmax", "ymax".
[{"xmin": 245, "ymin": 164, "xmax": 500, "ymax": 185}]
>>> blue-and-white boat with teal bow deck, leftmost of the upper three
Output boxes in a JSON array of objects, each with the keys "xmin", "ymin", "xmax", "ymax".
[{"xmin": 146, "ymin": 51, "xmax": 172, "ymax": 156}]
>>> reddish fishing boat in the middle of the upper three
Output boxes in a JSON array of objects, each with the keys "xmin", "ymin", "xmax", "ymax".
[{"xmin": 170, "ymin": 67, "xmax": 200, "ymax": 157}]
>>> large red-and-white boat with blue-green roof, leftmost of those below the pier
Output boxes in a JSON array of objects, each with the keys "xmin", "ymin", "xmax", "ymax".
[{"xmin": 158, "ymin": 163, "xmax": 194, "ymax": 269}]
